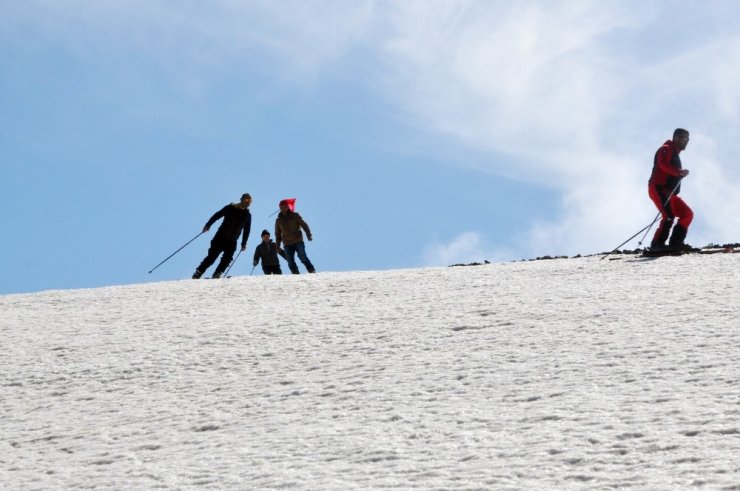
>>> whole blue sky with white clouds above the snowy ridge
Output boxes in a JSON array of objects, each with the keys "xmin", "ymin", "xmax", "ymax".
[{"xmin": 0, "ymin": 0, "xmax": 740, "ymax": 293}]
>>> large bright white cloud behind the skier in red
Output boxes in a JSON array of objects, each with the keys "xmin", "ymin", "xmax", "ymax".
[{"xmin": 372, "ymin": 2, "xmax": 740, "ymax": 254}]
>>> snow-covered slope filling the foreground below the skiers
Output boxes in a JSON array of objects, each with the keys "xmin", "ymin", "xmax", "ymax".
[{"xmin": 0, "ymin": 254, "xmax": 740, "ymax": 490}]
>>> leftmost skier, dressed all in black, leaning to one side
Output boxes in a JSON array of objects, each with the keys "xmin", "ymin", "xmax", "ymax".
[{"xmin": 193, "ymin": 193, "xmax": 252, "ymax": 280}]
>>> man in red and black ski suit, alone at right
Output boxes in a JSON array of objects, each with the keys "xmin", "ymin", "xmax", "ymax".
[{"xmin": 648, "ymin": 128, "xmax": 694, "ymax": 250}]
